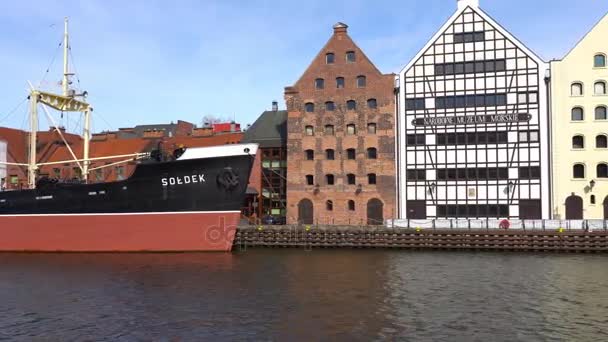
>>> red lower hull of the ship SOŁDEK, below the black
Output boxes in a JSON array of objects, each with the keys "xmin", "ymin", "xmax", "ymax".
[{"xmin": 0, "ymin": 211, "xmax": 240, "ymax": 252}]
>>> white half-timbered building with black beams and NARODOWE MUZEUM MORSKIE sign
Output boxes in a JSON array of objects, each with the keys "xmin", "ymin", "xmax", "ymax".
[{"xmin": 396, "ymin": 0, "xmax": 550, "ymax": 219}]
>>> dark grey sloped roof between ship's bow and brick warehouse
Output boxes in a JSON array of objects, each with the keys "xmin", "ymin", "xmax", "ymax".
[{"xmin": 243, "ymin": 110, "xmax": 287, "ymax": 148}]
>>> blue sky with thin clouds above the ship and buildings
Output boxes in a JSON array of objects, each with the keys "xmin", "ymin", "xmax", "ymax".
[{"xmin": 0, "ymin": 0, "xmax": 608, "ymax": 131}]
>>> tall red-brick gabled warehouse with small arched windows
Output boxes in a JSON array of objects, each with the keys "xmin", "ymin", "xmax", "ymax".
[{"xmin": 285, "ymin": 23, "xmax": 395, "ymax": 224}]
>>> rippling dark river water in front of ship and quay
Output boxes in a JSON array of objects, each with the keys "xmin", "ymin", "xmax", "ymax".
[{"xmin": 0, "ymin": 249, "xmax": 608, "ymax": 341}]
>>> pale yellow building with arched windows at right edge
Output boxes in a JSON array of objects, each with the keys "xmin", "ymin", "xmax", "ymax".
[{"xmin": 551, "ymin": 15, "xmax": 608, "ymax": 219}]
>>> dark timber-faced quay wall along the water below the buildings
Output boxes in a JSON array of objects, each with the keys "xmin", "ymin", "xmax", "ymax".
[{"xmin": 234, "ymin": 225, "xmax": 608, "ymax": 253}]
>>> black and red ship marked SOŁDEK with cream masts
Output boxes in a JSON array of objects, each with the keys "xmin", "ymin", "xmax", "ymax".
[{"xmin": 0, "ymin": 18, "xmax": 258, "ymax": 252}]
